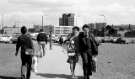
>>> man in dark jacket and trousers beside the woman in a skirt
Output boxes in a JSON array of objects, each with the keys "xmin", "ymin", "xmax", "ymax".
[{"xmin": 78, "ymin": 25, "xmax": 98, "ymax": 79}]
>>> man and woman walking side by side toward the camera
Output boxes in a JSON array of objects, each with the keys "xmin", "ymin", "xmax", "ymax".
[{"xmin": 63, "ymin": 25, "xmax": 99, "ymax": 79}]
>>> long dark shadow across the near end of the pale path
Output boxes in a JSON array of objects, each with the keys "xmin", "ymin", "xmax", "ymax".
[{"xmin": 37, "ymin": 73, "xmax": 82, "ymax": 79}]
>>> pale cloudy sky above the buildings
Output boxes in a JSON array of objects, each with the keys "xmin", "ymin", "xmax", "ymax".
[{"xmin": 0, "ymin": 0, "xmax": 135, "ymax": 26}]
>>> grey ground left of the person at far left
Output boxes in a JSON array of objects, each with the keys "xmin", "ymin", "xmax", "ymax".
[{"xmin": 0, "ymin": 43, "xmax": 20, "ymax": 79}]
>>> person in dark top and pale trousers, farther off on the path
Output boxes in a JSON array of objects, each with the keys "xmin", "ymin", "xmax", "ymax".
[{"xmin": 37, "ymin": 32, "xmax": 47, "ymax": 57}]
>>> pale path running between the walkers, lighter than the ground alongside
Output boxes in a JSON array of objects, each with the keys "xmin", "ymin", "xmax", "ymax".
[{"xmin": 31, "ymin": 45, "xmax": 82, "ymax": 79}]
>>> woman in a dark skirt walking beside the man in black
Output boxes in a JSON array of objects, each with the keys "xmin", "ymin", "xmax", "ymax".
[{"xmin": 66, "ymin": 27, "xmax": 80, "ymax": 78}]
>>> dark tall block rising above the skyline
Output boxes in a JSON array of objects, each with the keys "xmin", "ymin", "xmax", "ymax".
[{"xmin": 59, "ymin": 13, "xmax": 74, "ymax": 26}]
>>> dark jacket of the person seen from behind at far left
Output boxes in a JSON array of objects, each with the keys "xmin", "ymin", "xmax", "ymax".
[{"xmin": 16, "ymin": 34, "xmax": 33, "ymax": 55}]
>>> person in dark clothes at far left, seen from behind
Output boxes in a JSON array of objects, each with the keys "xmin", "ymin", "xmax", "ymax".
[{"xmin": 15, "ymin": 26, "xmax": 33, "ymax": 79}]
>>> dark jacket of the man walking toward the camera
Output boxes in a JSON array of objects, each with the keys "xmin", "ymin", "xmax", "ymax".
[{"xmin": 78, "ymin": 32, "xmax": 99, "ymax": 56}]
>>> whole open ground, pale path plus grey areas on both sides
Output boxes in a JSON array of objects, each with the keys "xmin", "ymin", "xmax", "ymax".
[{"xmin": 0, "ymin": 44, "xmax": 135, "ymax": 79}]
